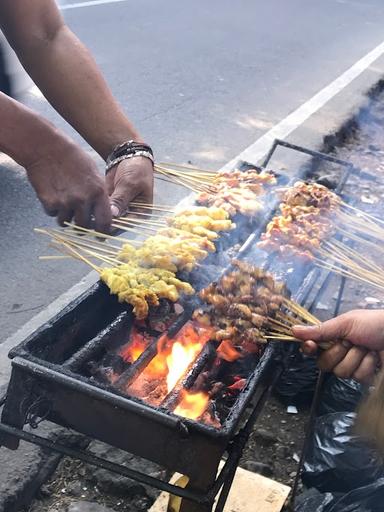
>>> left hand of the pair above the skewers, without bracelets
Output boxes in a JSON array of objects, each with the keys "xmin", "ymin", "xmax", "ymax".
[{"xmin": 25, "ymin": 137, "xmax": 112, "ymax": 233}]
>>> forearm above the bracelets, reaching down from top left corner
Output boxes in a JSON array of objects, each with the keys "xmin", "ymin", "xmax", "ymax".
[{"xmin": 0, "ymin": 0, "xmax": 140, "ymax": 159}]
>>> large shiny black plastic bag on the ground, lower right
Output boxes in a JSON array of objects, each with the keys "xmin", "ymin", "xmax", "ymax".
[{"xmin": 302, "ymin": 413, "xmax": 384, "ymax": 492}]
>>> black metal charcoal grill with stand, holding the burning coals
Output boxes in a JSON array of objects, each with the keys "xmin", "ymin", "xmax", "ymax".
[{"xmin": 0, "ymin": 141, "xmax": 374, "ymax": 512}]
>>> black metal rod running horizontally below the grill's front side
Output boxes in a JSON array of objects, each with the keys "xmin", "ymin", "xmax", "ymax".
[{"xmin": 0, "ymin": 423, "xmax": 208, "ymax": 503}]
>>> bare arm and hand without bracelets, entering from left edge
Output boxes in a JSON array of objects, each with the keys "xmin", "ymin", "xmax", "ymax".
[{"xmin": 0, "ymin": 93, "xmax": 111, "ymax": 232}]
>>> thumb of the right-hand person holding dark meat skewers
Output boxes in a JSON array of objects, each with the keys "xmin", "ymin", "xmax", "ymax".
[{"xmin": 292, "ymin": 315, "xmax": 351, "ymax": 342}]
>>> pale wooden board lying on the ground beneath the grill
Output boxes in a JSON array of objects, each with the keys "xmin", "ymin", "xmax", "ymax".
[{"xmin": 148, "ymin": 468, "xmax": 291, "ymax": 512}]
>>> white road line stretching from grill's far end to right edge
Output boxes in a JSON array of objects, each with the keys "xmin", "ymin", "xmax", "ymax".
[{"xmin": 223, "ymin": 42, "xmax": 384, "ymax": 169}]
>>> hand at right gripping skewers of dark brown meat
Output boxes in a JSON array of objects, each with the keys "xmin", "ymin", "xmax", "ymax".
[{"xmin": 293, "ymin": 310, "xmax": 384, "ymax": 383}]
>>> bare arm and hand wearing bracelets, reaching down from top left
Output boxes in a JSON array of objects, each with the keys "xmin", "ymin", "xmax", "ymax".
[{"xmin": 0, "ymin": 0, "xmax": 153, "ymax": 216}]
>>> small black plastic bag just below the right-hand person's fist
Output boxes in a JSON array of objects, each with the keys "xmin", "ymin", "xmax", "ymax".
[{"xmin": 317, "ymin": 374, "xmax": 364, "ymax": 416}]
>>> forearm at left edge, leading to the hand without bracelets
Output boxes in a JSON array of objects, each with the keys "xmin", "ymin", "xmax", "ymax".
[{"xmin": 0, "ymin": 93, "xmax": 60, "ymax": 167}]
